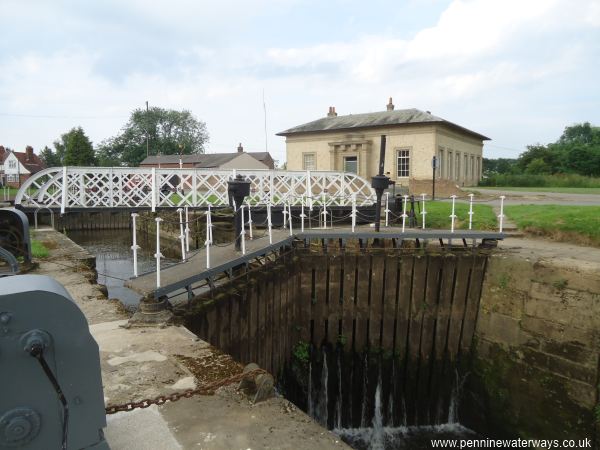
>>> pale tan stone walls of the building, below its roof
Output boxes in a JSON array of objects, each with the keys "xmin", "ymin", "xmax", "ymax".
[{"xmin": 286, "ymin": 125, "xmax": 483, "ymax": 186}]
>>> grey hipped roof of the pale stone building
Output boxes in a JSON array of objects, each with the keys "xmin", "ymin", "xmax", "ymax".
[{"xmin": 277, "ymin": 108, "xmax": 490, "ymax": 141}]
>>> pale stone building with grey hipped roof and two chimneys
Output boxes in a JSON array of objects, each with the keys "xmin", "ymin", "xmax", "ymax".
[{"xmin": 277, "ymin": 98, "xmax": 489, "ymax": 190}]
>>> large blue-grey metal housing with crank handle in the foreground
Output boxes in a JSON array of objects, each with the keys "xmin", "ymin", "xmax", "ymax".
[{"xmin": 0, "ymin": 275, "xmax": 109, "ymax": 450}]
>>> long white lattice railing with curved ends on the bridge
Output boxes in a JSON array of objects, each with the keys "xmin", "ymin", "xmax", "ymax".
[{"xmin": 15, "ymin": 167, "xmax": 375, "ymax": 213}]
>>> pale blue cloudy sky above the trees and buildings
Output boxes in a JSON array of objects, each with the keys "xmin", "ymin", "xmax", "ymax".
[{"xmin": 0, "ymin": 0, "xmax": 600, "ymax": 162}]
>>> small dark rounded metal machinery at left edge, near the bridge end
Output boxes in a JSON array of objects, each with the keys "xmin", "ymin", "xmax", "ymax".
[{"xmin": 0, "ymin": 208, "xmax": 31, "ymax": 276}]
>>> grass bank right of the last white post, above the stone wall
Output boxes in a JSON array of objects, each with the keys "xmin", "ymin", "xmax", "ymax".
[{"xmin": 504, "ymin": 205, "xmax": 600, "ymax": 247}]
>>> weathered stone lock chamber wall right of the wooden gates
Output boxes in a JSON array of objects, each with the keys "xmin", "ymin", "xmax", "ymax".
[{"xmin": 471, "ymin": 248, "xmax": 600, "ymax": 439}]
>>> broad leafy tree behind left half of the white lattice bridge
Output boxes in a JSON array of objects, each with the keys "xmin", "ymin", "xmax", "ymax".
[{"xmin": 98, "ymin": 107, "xmax": 208, "ymax": 166}]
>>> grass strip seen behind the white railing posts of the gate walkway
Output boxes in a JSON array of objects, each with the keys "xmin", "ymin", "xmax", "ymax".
[{"xmin": 416, "ymin": 202, "xmax": 498, "ymax": 230}]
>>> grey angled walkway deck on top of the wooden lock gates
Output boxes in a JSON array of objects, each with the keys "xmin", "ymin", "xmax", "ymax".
[{"xmin": 125, "ymin": 227, "xmax": 504, "ymax": 297}]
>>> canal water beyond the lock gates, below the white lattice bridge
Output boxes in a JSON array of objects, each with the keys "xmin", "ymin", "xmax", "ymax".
[{"xmin": 67, "ymin": 230, "xmax": 176, "ymax": 308}]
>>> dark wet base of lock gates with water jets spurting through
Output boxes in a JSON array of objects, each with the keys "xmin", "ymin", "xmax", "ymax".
[{"xmin": 280, "ymin": 345, "xmax": 474, "ymax": 450}]
